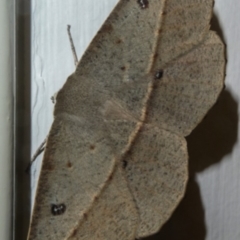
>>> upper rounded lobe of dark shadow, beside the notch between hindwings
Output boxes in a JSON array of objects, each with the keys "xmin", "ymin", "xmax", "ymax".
[{"xmin": 187, "ymin": 90, "xmax": 238, "ymax": 173}]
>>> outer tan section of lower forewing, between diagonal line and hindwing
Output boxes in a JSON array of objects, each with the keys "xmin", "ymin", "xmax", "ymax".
[{"xmin": 67, "ymin": 167, "xmax": 139, "ymax": 240}]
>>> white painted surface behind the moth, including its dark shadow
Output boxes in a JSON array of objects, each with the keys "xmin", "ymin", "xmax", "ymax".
[{"xmin": 32, "ymin": 0, "xmax": 240, "ymax": 240}]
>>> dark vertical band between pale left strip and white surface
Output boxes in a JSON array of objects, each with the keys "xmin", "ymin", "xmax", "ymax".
[{"xmin": 13, "ymin": 0, "xmax": 31, "ymax": 240}]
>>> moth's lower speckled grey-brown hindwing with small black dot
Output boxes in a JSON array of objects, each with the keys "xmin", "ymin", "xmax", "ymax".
[{"xmin": 123, "ymin": 125, "xmax": 188, "ymax": 238}]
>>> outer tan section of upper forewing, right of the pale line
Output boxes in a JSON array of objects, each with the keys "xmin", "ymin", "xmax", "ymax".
[{"xmin": 157, "ymin": 0, "xmax": 214, "ymax": 67}]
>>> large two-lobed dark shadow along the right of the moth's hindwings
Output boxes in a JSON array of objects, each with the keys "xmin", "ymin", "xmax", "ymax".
[{"xmin": 144, "ymin": 90, "xmax": 238, "ymax": 240}]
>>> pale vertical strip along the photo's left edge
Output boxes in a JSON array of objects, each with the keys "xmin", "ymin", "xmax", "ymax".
[{"xmin": 0, "ymin": 0, "xmax": 14, "ymax": 240}]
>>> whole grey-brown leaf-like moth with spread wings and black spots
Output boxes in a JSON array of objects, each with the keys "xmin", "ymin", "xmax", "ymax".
[{"xmin": 28, "ymin": 0, "xmax": 225, "ymax": 240}]
